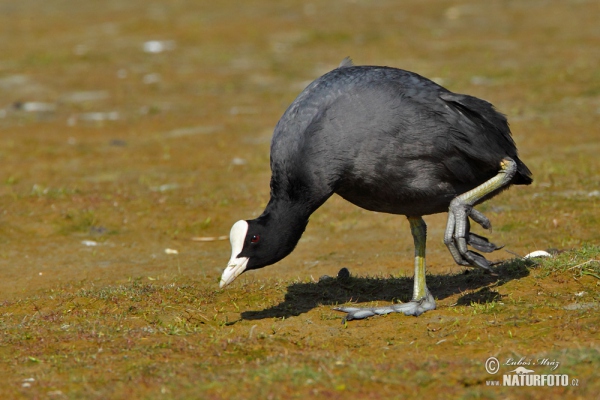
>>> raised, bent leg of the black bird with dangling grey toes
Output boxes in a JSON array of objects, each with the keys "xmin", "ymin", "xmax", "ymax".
[{"xmin": 444, "ymin": 157, "xmax": 517, "ymax": 271}]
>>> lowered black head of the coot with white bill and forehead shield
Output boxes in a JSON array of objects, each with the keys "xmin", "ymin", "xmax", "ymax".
[{"xmin": 219, "ymin": 216, "xmax": 306, "ymax": 287}]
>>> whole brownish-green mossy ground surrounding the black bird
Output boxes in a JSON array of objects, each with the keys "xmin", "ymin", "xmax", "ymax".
[{"xmin": 0, "ymin": 0, "xmax": 600, "ymax": 399}]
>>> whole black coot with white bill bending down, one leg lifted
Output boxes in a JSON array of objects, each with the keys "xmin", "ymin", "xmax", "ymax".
[{"xmin": 220, "ymin": 58, "xmax": 532, "ymax": 320}]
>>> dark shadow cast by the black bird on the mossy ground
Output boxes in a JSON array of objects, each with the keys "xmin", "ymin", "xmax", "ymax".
[{"xmin": 241, "ymin": 259, "xmax": 535, "ymax": 320}]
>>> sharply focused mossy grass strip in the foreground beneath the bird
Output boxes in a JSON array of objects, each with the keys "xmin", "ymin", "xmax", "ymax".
[{"xmin": 0, "ymin": 247, "xmax": 600, "ymax": 398}]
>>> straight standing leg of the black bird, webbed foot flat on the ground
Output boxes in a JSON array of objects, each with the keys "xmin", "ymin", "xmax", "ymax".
[{"xmin": 334, "ymin": 217, "xmax": 435, "ymax": 321}]
